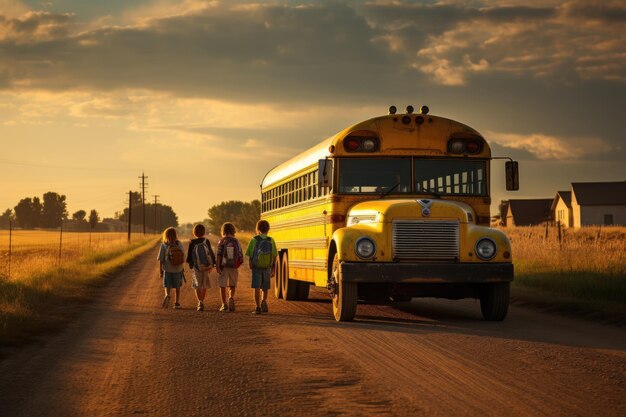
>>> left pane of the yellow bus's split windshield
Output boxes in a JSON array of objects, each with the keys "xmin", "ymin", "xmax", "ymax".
[{"xmin": 339, "ymin": 158, "xmax": 411, "ymax": 194}]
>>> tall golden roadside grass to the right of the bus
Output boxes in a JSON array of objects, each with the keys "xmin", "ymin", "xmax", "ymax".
[{"xmin": 506, "ymin": 227, "xmax": 626, "ymax": 324}]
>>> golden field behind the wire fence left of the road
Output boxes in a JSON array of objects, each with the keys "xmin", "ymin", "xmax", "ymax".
[{"xmin": 0, "ymin": 221, "xmax": 154, "ymax": 280}]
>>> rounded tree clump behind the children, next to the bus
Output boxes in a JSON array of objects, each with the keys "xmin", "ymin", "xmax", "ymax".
[{"xmin": 204, "ymin": 200, "xmax": 261, "ymax": 234}]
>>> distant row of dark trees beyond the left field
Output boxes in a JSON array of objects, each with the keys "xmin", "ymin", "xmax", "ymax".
[{"xmin": 0, "ymin": 191, "xmax": 178, "ymax": 231}]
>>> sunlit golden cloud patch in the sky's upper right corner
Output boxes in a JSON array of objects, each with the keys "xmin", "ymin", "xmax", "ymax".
[{"xmin": 363, "ymin": 1, "xmax": 626, "ymax": 86}]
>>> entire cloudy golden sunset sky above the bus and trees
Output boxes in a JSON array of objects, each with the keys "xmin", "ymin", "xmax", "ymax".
[{"xmin": 0, "ymin": 0, "xmax": 626, "ymax": 221}]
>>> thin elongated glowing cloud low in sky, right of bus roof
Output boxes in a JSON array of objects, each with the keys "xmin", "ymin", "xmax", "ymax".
[{"xmin": 487, "ymin": 132, "xmax": 613, "ymax": 161}]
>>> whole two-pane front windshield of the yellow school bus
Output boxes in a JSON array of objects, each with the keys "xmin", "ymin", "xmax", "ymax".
[{"xmin": 339, "ymin": 158, "xmax": 487, "ymax": 196}]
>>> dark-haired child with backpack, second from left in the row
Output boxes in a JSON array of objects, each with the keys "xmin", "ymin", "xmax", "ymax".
[{"xmin": 187, "ymin": 224, "xmax": 215, "ymax": 311}]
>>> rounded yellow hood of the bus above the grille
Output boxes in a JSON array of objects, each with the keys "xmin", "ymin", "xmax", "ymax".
[{"xmin": 347, "ymin": 198, "xmax": 476, "ymax": 226}]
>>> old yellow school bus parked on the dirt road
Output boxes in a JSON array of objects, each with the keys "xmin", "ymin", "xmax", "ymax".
[{"xmin": 261, "ymin": 106, "xmax": 518, "ymax": 321}]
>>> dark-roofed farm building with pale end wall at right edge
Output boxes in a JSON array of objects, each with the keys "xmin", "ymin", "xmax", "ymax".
[{"xmin": 571, "ymin": 181, "xmax": 626, "ymax": 227}]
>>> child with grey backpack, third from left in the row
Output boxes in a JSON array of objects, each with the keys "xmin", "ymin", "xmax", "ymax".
[{"xmin": 216, "ymin": 222, "xmax": 243, "ymax": 311}]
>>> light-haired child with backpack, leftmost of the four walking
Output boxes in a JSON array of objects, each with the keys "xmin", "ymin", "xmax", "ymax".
[{"xmin": 157, "ymin": 227, "xmax": 185, "ymax": 310}]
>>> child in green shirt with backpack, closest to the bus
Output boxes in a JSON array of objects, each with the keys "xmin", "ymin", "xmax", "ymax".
[{"xmin": 246, "ymin": 220, "xmax": 278, "ymax": 314}]
